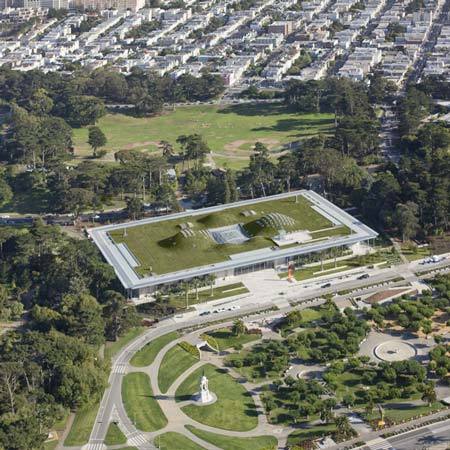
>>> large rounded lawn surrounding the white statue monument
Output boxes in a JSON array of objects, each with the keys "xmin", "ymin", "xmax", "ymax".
[{"xmin": 176, "ymin": 364, "xmax": 258, "ymax": 431}]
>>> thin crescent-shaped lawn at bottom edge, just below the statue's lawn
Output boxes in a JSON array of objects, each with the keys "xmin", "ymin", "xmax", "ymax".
[{"xmin": 186, "ymin": 425, "xmax": 278, "ymax": 450}]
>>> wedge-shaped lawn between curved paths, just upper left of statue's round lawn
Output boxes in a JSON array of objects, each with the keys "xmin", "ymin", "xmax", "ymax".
[{"xmin": 158, "ymin": 345, "xmax": 199, "ymax": 394}]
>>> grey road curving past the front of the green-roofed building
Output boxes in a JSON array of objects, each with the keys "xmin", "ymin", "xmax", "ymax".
[{"xmin": 80, "ymin": 258, "xmax": 450, "ymax": 450}]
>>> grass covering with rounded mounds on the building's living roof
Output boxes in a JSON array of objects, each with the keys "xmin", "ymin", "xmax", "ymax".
[{"xmin": 110, "ymin": 195, "xmax": 340, "ymax": 275}]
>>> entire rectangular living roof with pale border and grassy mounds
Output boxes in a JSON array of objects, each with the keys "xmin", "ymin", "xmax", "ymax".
[{"xmin": 88, "ymin": 190, "xmax": 377, "ymax": 289}]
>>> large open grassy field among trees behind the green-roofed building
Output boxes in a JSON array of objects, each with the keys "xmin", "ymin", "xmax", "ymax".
[{"xmin": 74, "ymin": 104, "xmax": 334, "ymax": 167}]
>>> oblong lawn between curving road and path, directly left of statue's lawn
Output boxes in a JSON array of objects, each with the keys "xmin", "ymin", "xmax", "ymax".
[{"xmin": 122, "ymin": 372, "xmax": 167, "ymax": 431}]
